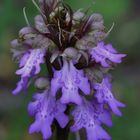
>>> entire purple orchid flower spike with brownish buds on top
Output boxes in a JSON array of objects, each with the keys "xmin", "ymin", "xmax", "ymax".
[{"xmin": 11, "ymin": 0, "xmax": 125, "ymax": 140}]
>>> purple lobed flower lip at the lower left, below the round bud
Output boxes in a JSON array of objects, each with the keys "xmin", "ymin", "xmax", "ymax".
[{"xmin": 28, "ymin": 91, "xmax": 68, "ymax": 140}]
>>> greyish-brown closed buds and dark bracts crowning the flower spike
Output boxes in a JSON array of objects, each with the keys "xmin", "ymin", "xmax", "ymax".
[{"xmin": 10, "ymin": 0, "xmax": 105, "ymax": 61}]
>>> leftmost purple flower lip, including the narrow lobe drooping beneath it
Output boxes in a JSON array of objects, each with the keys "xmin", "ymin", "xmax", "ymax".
[{"xmin": 13, "ymin": 48, "xmax": 46, "ymax": 95}]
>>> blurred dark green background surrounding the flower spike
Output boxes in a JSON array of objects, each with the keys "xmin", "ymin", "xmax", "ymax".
[{"xmin": 0, "ymin": 0, "xmax": 140, "ymax": 140}]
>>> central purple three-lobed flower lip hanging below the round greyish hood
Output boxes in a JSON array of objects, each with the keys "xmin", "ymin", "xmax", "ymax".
[{"xmin": 51, "ymin": 61, "xmax": 90, "ymax": 104}]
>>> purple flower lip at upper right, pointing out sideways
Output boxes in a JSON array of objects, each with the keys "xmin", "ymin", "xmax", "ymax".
[{"xmin": 90, "ymin": 42, "xmax": 126, "ymax": 67}]
